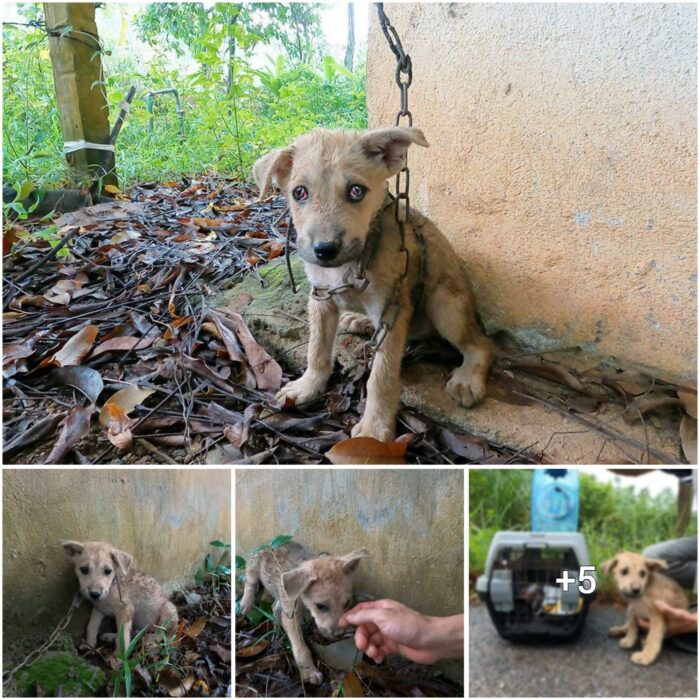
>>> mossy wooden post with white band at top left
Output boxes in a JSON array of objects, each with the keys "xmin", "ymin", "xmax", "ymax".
[{"xmin": 44, "ymin": 2, "xmax": 117, "ymax": 194}]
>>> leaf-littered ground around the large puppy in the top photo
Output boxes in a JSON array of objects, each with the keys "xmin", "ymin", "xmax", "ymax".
[{"xmin": 3, "ymin": 175, "xmax": 697, "ymax": 464}]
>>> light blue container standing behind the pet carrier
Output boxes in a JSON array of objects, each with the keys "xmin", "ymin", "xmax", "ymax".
[{"xmin": 530, "ymin": 469, "xmax": 579, "ymax": 532}]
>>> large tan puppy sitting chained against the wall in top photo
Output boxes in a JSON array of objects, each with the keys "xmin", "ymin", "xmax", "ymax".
[{"xmin": 253, "ymin": 127, "xmax": 493, "ymax": 441}]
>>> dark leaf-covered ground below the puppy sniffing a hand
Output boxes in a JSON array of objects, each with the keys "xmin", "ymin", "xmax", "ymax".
[{"xmin": 235, "ymin": 610, "xmax": 464, "ymax": 698}]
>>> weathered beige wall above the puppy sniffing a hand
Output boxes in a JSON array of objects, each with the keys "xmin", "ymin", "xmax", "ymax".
[{"xmin": 236, "ymin": 469, "xmax": 464, "ymax": 615}]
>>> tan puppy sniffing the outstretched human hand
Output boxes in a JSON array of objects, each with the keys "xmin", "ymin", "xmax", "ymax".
[{"xmin": 240, "ymin": 542, "xmax": 369, "ymax": 685}]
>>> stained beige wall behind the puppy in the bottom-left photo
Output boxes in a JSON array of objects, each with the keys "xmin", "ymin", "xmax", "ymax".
[{"xmin": 3, "ymin": 469, "xmax": 231, "ymax": 646}]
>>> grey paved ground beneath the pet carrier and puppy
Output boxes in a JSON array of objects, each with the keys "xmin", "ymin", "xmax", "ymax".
[{"xmin": 469, "ymin": 603, "xmax": 698, "ymax": 697}]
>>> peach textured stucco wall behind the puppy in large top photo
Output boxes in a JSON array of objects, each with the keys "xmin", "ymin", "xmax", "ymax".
[{"xmin": 367, "ymin": 3, "xmax": 697, "ymax": 379}]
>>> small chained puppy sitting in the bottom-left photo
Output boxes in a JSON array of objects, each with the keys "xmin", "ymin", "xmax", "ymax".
[{"xmin": 60, "ymin": 540, "xmax": 177, "ymax": 649}]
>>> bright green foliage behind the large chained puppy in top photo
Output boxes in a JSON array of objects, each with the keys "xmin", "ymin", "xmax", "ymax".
[{"xmin": 3, "ymin": 3, "xmax": 367, "ymax": 187}]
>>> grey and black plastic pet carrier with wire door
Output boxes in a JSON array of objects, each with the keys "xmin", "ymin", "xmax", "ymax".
[{"xmin": 476, "ymin": 532, "xmax": 594, "ymax": 642}]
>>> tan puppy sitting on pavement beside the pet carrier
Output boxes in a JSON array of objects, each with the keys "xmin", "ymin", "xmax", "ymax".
[{"xmin": 600, "ymin": 552, "xmax": 688, "ymax": 666}]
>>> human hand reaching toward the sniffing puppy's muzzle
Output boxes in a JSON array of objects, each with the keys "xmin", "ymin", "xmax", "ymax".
[{"xmin": 340, "ymin": 599, "xmax": 464, "ymax": 664}]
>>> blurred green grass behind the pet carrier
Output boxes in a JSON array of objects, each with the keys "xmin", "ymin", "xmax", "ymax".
[{"xmin": 469, "ymin": 469, "xmax": 697, "ymax": 588}]
